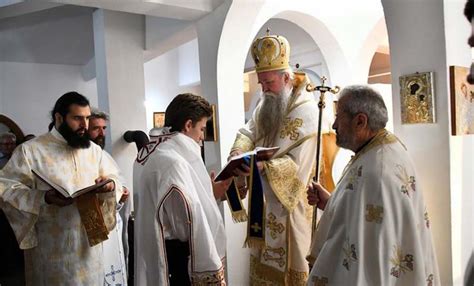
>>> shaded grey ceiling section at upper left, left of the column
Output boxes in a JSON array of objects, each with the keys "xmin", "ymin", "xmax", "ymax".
[{"xmin": 0, "ymin": 6, "xmax": 94, "ymax": 65}]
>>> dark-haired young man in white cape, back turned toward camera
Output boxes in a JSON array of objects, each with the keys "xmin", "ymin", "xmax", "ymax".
[{"xmin": 135, "ymin": 94, "xmax": 230, "ymax": 286}]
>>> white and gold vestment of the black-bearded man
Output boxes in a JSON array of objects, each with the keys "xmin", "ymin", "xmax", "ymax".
[{"xmin": 0, "ymin": 128, "xmax": 122, "ymax": 286}]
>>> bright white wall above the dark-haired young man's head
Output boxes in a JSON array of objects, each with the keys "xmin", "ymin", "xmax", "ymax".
[{"xmin": 145, "ymin": 40, "xmax": 202, "ymax": 130}]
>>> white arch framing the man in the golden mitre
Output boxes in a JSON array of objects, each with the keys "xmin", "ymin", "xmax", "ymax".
[{"xmin": 213, "ymin": 1, "xmax": 350, "ymax": 285}]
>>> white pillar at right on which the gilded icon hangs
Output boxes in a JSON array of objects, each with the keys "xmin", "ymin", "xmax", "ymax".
[{"xmin": 382, "ymin": 0, "xmax": 472, "ymax": 285}]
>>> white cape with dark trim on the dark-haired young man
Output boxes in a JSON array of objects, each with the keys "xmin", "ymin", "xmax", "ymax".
[{"xmin": 135, "ymin": 133, "xmax": 226, "ymax": 286}]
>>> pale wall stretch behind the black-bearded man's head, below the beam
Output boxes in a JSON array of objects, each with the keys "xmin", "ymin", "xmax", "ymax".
[{"xmin": 0, "ymin": 62, "xmax": 97, "ymax": 135}]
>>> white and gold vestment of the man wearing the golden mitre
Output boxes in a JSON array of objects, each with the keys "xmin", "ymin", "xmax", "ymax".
[{"xmin": 232, "ymin": 79, "xmax": 329, "ymax": 286}]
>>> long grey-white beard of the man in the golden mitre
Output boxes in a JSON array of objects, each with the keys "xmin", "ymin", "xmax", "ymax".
[{"xmin": 257, "ymin": 87, "xmax": 291, "ymax": 147}]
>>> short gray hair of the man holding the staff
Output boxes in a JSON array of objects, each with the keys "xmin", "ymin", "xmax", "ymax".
[{"xmin": 338, "ymin": 85, "xmax": 388, "ymax": 131}]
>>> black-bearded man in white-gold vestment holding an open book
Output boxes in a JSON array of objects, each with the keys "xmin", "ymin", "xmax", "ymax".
[{"xmin": 0, "ymin": 92, "xmax": 122, "ymax": 286}]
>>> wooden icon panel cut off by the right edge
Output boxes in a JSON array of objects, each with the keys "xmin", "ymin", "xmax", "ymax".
[{"xmin": 449, "ymin": 66, "xmax": 474, "ymax": 135}]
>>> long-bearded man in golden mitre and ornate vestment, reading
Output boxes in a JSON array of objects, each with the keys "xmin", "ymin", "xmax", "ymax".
[{"xmin": 230, "ymin": 31, "xmax": 329, "ymax": 285}]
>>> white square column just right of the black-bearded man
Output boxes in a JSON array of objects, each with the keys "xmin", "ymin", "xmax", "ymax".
[{"xmin": 93, "ymin": 9, "xmax": 146, "ymax": 197}]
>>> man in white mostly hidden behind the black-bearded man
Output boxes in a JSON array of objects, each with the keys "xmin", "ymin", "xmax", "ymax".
[{"xmin": 87, "ymin": 108, "xmax": 129, "ymax": 286}]
